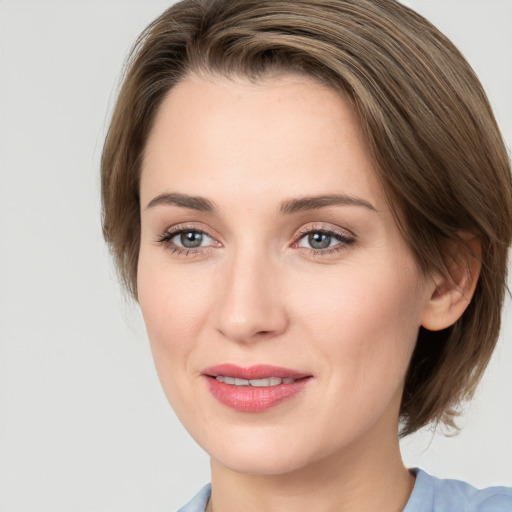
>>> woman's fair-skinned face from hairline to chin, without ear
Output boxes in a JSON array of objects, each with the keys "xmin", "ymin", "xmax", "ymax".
[{"xmin": 138, "ymin": 75, "xmax": 433, "ymax": 474}]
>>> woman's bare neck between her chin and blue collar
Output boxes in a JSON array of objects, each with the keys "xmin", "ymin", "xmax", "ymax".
[{"xmin": 207, "ymin": 435, "xmax": 414, "ymax": 512}]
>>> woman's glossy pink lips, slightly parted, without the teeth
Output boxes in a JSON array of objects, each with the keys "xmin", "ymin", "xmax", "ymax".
[{"xmin": 202, "ymin": 364, "xmax": 312, "ymax": 412}]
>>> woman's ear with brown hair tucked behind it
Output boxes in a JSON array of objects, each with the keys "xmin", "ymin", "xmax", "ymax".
[{"xmin": 421, "ymin": 233, "xmax": 482, "ymax": 331}]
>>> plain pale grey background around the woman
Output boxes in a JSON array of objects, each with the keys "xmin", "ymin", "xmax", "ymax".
[{"xmin": 0, "ymin": 0, "xmax": 512, "ymax": 512}]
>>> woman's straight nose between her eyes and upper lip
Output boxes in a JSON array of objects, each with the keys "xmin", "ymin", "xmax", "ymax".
[{"xmin": 215, "ymin": 251, "xmax": 289, "ymax": 343}]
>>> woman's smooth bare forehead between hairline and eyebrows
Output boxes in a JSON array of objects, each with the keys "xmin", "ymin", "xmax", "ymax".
[{"xmin": 141, "ymin": 74, "xmax": 382, "ymax": 209}]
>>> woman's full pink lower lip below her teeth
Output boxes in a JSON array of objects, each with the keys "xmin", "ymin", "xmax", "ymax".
[{"xmin": 205, "ymin": 377, "xmax": 311, "ymax": 412}]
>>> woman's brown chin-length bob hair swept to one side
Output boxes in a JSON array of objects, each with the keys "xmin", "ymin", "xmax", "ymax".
[{"xmin": 101, "ymin": 0, "xmax": 512, "ymax": 436}]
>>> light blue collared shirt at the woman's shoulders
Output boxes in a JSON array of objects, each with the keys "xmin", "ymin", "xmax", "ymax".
[{"xmin": 178, "ymin": 469, "xmax": 512, "ymax": 512}]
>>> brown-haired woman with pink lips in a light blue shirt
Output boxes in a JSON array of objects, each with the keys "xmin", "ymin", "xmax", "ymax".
[{"xmin": 102, "ymin": 0, "xmax": 512, "ymax": 512}]
